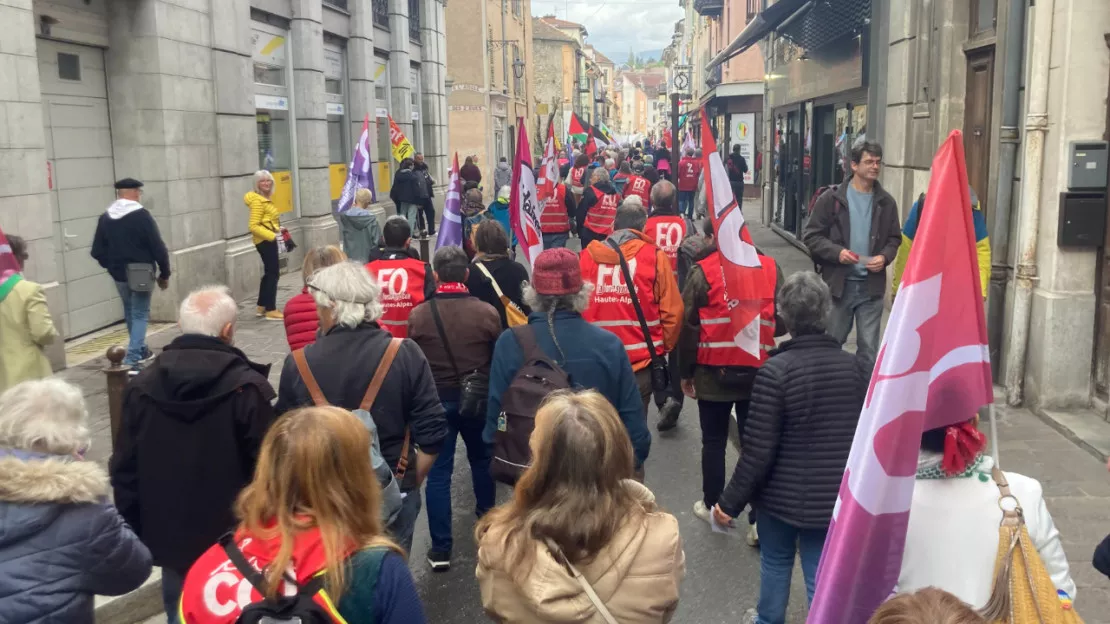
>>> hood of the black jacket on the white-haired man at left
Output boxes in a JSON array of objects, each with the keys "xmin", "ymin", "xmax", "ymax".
[{"xmin": 130, "ymin": 334, "xmax": 275, "ymax": 422}]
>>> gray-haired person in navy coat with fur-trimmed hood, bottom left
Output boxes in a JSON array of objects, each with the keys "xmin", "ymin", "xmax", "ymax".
[{"xmin": 0, "ymin": 379, "xmax": 151, "ymax": 624}]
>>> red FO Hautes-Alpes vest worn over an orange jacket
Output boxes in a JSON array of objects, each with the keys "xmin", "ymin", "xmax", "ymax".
[{"xmin": 579, "ymin": 244, "xmax": 663, "ymax": 364}]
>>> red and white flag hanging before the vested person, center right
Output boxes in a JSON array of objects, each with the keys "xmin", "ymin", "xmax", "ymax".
[{"xmin": 697, "ymin": 114, "xmax": 775, "ymax": 358}]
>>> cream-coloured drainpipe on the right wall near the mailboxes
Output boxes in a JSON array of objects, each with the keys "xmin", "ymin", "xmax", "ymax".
[{"xmin": 1006, "ymin": 0, "xmax": 1056, "ymax": 406}]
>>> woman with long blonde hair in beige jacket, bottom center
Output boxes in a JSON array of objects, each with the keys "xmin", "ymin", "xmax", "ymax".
[{"xmin": 475, "ymin": 391, "xmax": 686, "ymax": 624}]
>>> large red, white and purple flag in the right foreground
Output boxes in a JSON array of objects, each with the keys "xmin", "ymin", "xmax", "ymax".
[{"xmin": 807, "ymin": 131, "xmax": 993, "ymax": 624}]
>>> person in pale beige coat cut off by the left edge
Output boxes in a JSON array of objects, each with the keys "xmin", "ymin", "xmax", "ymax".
[{"xmin": 0, "ymin": 235, "xmax": 58, "ymax": 392}]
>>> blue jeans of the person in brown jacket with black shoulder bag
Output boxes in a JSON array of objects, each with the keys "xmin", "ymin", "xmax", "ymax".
[{"xmin": 424, "ymin": 401, "xmax": 495, "ymax": 553}]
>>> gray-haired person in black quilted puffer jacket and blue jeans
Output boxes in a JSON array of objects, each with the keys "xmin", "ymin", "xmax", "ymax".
[{"xmin": 714, "ymin": 271, "xmax": 868, "ymax": 622}]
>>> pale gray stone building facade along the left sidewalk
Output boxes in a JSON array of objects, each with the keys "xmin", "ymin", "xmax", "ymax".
[{"xmin": 0, "ymin": 0, "xmax": 447, "ymax": 366}]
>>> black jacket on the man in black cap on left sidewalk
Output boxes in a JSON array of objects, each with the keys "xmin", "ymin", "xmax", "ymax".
[{"xmin": 90, "ymin": 208, "xmax": 170, "ymax": 282}]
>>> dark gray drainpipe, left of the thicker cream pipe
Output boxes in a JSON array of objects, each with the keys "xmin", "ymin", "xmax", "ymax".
[{"xmin": 987, "ymin": 0, "xmax": 1028, "ymax": 379}]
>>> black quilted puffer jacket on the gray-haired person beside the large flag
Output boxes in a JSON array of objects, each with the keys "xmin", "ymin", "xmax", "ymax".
[{"xmin": 718, "ymin": 334, "xmax": 868, "ymax": 529}]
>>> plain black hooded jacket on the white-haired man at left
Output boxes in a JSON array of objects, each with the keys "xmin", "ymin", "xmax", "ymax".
[{"xmin": 110, "ymin": 334, "xmax": 274, "ymax": 572}]
